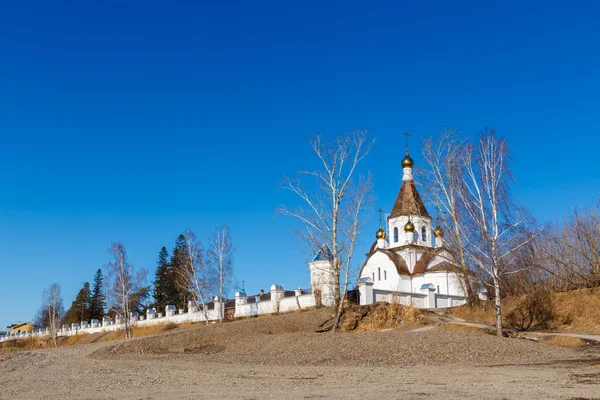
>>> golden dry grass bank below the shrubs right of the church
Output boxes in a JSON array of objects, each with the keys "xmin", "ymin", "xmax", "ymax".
[{"xmin": 452, "ymin": 288, "xmax": 600, "ymax": 334}]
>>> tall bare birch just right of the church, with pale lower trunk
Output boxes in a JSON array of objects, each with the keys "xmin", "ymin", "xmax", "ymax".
[{"xmin": 457, "ymin": 131, "xmax": 536, "ymax": 336}]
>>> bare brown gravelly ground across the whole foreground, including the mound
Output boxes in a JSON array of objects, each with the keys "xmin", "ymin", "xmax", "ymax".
[{"xmin": 0, "ymin": 310, "xmax": 600, "ymax": 399}]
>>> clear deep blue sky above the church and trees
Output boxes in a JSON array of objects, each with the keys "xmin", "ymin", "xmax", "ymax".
[{"xmin": 0, "ymin": 1, "xmax": 600, "ymax": 327}]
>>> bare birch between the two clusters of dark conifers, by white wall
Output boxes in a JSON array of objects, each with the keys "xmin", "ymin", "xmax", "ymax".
[{"xmin": 106, "ymin": 242, "xmax": 146, "ymax": 339}]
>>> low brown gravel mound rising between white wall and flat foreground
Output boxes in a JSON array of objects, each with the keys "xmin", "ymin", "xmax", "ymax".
[{"xmin": 94, "ymin": 305, "xmax": 574, "ymax": 365}]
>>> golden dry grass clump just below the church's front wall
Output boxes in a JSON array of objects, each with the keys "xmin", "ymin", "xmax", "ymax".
[{"xmin": 340, "ymin": 303, "xmax": 429, "ymax": 332}]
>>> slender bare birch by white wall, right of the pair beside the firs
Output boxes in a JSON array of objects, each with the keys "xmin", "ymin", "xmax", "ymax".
[{"xmin": 207, "ymin": 225, "xmax": 233, "ymax": 321}]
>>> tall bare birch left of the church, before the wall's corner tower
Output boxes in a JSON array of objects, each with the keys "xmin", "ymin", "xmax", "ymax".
[{"xmin": 281, "ymin": 131, "xmax": 374, "ymax": 332}]
